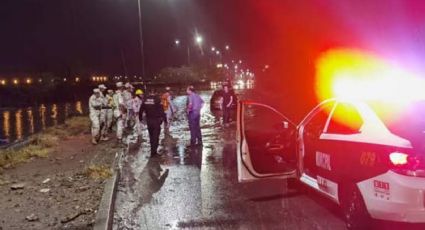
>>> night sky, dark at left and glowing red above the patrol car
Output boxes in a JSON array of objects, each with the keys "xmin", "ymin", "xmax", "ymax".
[{"xmin": 0, "ymin": 0, "xmax": 425, "ymax": 91}]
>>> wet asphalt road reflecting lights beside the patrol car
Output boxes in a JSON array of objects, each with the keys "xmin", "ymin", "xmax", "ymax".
[{"xmin": 114, "ymin": 92, "xmax": 345, "ymax": 230}]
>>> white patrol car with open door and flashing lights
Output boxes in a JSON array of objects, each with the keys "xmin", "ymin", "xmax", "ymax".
[{"xmin": 237, "ymin": 99, "xmax": 425, "ymax": 229}]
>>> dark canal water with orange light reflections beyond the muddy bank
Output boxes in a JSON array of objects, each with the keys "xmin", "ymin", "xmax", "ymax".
[{"xmin": 0, "ymin": 101, "xmax": 88, "ymax": 146}]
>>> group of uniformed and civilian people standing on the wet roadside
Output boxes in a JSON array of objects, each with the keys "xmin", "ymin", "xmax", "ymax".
[{"xmin": 89, "ymin": 82, "xmax": 204, "ymax": 157}]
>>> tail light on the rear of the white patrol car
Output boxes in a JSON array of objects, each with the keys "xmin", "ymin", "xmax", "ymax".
[{"xmin": 389, "ymin": 152, "xmax": 425, "ymax": 177}]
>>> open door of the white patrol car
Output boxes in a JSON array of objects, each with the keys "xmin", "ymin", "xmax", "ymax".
[{"xmin": 236, "ymin": 100, "xmax": 297, "ymax": 182}]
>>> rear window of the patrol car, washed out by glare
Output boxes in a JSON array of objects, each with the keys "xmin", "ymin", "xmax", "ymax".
[{"xmin": 369, "ymin": 101, "xmax": 425, "ymax": 150}]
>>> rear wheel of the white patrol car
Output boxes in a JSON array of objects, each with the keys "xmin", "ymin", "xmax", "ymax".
[{"xmin": 342, "ymin": 184, "xmax": 371, "ymax": 230}]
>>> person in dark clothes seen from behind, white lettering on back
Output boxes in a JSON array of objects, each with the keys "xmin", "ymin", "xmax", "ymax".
[{"xmin": 139, "ymin": 89, "xmax": 165, "ymax": 157}]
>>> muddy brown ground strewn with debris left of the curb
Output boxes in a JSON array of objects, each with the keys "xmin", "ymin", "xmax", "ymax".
[{"xmin": 0, "ymin": 118, "xmax": 119, "ymax": 230}]
